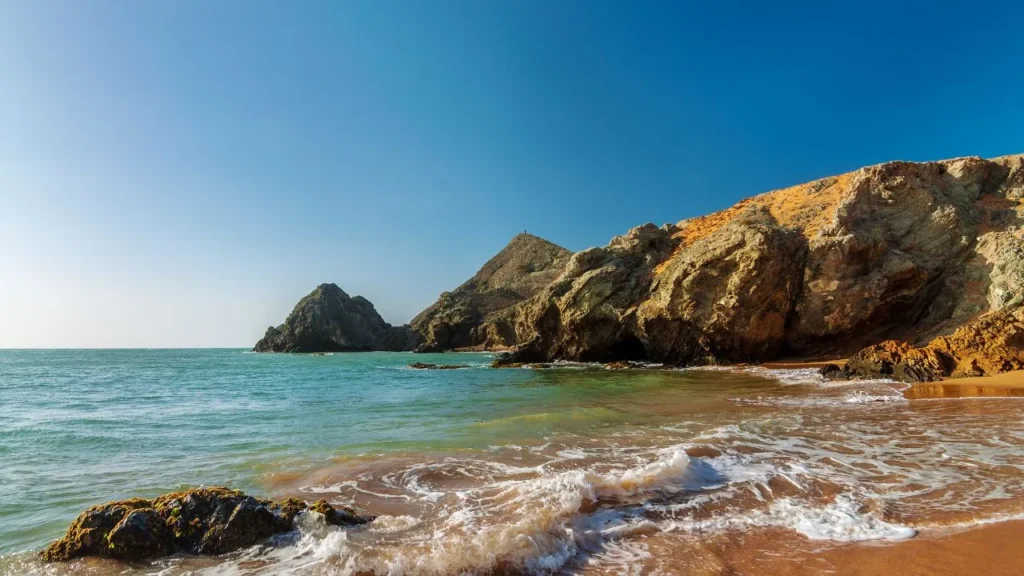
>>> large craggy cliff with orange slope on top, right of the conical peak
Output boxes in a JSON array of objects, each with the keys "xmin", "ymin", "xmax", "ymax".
[{"xmin": 493, "ymin": 156, "xmax": 1024, "ymax": 372}]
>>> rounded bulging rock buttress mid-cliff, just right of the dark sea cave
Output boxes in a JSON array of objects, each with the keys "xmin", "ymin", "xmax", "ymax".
[{"xmin": 637, "ymin": 209, "xmax": 807, "ymax": 364}]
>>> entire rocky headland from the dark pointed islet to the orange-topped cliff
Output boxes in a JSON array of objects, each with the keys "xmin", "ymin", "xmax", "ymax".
[{"xmin": 255, "ymin": 155, "xmax": 1024, "ymax": 380}]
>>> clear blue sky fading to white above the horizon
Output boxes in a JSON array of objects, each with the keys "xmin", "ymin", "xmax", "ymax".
[{"xmin": 0, "ymin": 0, "xmax": 1024, "ymax": 347}]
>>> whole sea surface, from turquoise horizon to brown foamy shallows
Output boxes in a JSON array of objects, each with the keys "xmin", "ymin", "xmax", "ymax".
[{"xmin": 0, "ymin": 351, "xmax": 1024, "ymax": 575}]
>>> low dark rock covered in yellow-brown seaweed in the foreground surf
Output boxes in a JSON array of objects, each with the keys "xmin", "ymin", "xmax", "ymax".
[{"xmin": 40, "ymin": 487, "xmax": 373, "ymax": 562}]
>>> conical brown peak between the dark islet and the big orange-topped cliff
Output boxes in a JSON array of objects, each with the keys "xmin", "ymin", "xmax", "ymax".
[{"xmin": 412, "ymin": 233, "xmax": 571, "ymax": 352}]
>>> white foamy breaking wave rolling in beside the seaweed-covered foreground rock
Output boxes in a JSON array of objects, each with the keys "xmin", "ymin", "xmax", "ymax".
[{"xmin": 249, "ymin": 444, "xmax": 929, "ymax": 574}]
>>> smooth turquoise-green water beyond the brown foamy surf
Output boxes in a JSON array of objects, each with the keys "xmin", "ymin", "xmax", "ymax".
[{"xmin": 0, "ymin": 349, "xmax": 765, "ymax": 553}]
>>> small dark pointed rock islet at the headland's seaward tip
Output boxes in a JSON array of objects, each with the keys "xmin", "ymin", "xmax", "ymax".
[{"xmin": 253, "ymin": 284, "xmax": 420, "ymax": 353}]
